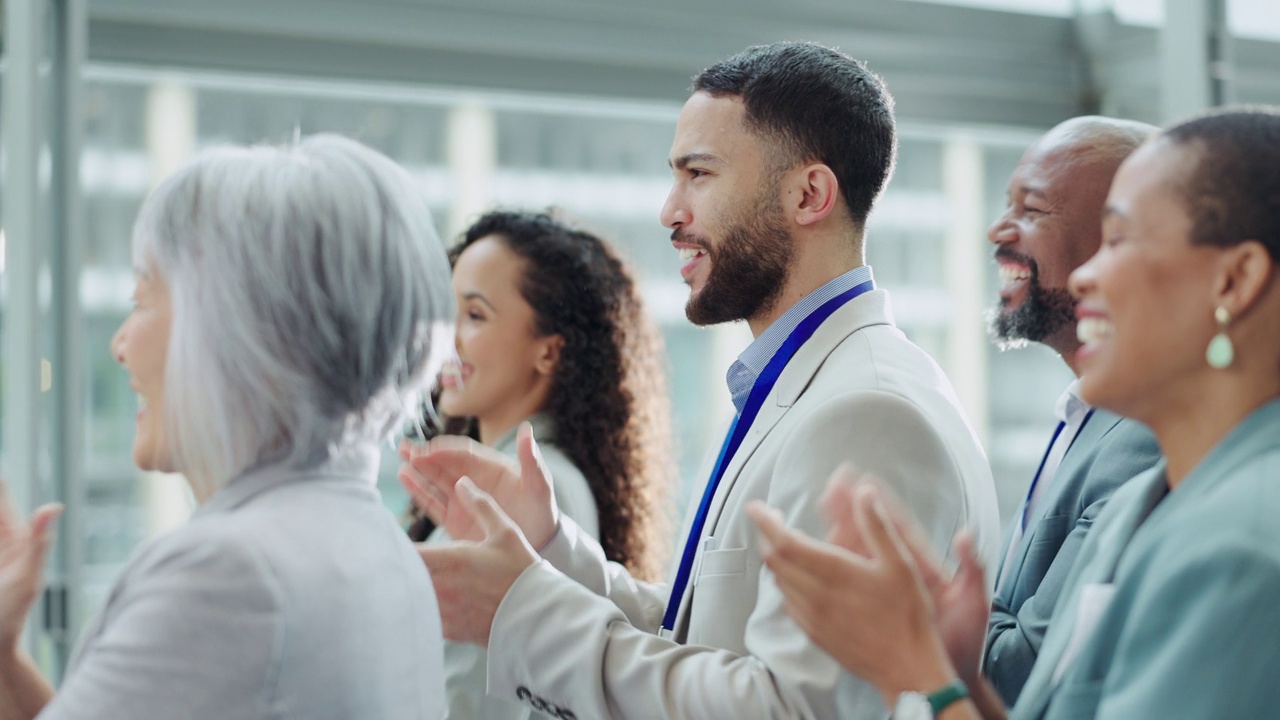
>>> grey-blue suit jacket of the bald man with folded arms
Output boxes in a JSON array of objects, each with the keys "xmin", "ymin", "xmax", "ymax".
[{"xmin": 983, "ymin": 410, "xmax": 1161, "ymax": 705}]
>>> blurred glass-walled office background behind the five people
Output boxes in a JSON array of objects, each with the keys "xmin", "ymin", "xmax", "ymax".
[{"xmin": 0, "ymin": 0, "xmax": 1280, "ymax": 675}]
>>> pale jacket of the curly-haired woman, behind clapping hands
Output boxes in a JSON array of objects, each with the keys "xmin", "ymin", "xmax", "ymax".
[{"xmin": 426, "ymin": 415, "xmax": 600, "ymax": 720}]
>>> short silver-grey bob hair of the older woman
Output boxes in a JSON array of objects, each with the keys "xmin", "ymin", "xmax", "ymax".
[{"xmin": 133, "ymin": 135, "xmax": 453, "ymax": 500}]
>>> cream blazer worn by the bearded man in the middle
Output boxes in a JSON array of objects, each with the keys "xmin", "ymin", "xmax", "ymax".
[{"xmin": 478, "ymin": 291, "xmax": 1000, "ymax": 720}]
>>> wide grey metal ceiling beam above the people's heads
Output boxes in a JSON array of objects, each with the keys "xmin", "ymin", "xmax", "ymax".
[{"xmin": 90, "ymin": 0, "xmax": 1082, "ymax": 126}]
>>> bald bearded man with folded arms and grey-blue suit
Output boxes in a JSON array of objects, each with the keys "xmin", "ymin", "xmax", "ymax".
[{"xmin": 982, "ymin": 117, "xmax": 1160, "ymax": 706}]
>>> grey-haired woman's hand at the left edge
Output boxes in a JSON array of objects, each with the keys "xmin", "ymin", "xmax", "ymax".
[{"xmin": 0, "ymin": 480, "xmax": 63, "ymax": 652}]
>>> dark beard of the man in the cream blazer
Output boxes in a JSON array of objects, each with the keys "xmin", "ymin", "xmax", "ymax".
[{"xmin": 672, "ymin": 192, "xmax": 795, "ymax": 325}]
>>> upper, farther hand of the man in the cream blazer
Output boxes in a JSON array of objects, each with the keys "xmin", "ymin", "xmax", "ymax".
[{"xmin": 398, "ymin": 423, "xmax": 559, "ymax": 547}]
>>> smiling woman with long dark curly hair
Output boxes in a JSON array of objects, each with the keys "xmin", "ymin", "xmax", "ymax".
[{"xmin": 402, "ymin": 211, "xmax": 675, "ymax": 717}]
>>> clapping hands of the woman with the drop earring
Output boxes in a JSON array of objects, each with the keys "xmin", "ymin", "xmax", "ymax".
[{"xmin": 748, "ymin": 468, "xmax": 988, "ymax": 706}]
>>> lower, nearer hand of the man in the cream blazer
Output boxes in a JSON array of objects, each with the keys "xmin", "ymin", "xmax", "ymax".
[{"xmin": 417, "ymin": 478, "xmax": 538, "ymax": 646}]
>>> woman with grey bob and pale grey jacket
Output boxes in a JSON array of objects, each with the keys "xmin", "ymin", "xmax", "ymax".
[{"xmin": 0, "ymin": 136, "xmax": 453, "ymax": 720}]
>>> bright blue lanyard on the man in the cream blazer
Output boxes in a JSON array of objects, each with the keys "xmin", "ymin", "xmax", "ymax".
[{"xmin": 662, "ymin": 281, "xmax": 876, "ymax": 633}]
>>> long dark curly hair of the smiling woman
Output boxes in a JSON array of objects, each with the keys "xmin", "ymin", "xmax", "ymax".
[{"xmin": 412, "ymin": 211, "xmax": 675, "ymax": 580}]
